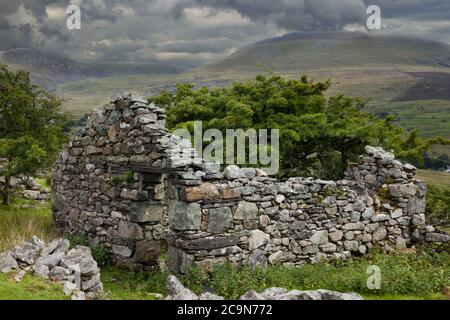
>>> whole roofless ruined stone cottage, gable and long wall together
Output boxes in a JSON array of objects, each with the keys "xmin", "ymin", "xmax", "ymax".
[{"xmin": 52, "ymin": 94, "xmax": 449, "ymax": 273}]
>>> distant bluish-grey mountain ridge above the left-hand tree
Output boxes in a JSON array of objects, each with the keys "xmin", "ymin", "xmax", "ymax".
[{"xmin": 0, "ymin": 48, "xmax": 184, "ymax": 91}]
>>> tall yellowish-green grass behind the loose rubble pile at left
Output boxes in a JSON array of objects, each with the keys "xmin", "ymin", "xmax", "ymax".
[{"xmin": 0, "ymin": 199, "xmax": 56, "ymax": 252}]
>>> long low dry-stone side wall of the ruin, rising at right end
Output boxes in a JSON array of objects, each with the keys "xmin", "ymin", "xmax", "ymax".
[{"xmin": 164, "ymin": 147, "xmax": 440, "ymax": 272}]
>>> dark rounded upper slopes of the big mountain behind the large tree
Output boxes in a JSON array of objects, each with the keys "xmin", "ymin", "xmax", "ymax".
[{"xmin": 190, "ymin": 32, "xmax": 450, "ymax": 74}]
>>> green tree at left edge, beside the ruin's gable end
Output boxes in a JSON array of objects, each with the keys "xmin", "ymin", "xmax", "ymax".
[{"xmin": 0, "ymin": 64, "xmax": 68, "ymax": 203}]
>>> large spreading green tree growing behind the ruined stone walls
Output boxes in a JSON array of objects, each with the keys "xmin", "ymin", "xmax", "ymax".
[{"xmin": 149, "ymin": 76, "xmax": 449, "ymax": 179}]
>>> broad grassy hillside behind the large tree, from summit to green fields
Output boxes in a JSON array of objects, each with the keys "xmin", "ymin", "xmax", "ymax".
[{"xmin": 176, "ymin": 32, "xmax": 450, "ymax": 142}]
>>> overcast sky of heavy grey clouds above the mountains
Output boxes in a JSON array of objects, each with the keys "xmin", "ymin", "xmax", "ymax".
[{"xmin": 0, "ymin": 0, "xmax": 450, "ymax": 66}]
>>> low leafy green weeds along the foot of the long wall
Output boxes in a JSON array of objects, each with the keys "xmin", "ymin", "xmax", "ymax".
[{"xmin": 182, "ymin": 247, "xmax": 450, "ymax": 299}]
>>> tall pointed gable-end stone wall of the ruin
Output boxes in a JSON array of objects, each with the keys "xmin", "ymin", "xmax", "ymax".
[{"xmin": 52, "ymin": 94, "xmax": 199, "ymax": 269}]
